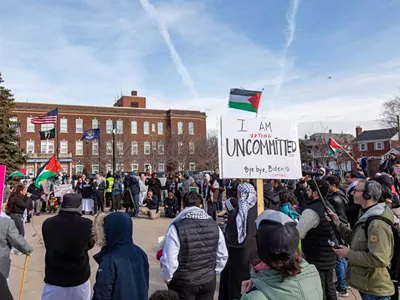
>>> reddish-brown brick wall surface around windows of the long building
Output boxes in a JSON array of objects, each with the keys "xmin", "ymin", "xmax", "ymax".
[{"xmin": 15, "ymin": 102, "xmax": 207, "ymax": 174}]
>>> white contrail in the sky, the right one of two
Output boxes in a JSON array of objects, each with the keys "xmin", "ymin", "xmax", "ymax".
[{"xmin": 275, "ymin": 0, "xmax": 300, "ymax": 100}]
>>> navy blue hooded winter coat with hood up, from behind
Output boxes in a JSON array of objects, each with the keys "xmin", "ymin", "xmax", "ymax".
[{"xmin": 93, "ymin": 212, "xmax": 149, "ymax": 300}]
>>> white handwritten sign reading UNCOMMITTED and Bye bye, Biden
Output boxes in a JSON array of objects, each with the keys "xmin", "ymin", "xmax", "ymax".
[{"xmin": 219, "ymin": 117, "xmax": 301, "ymax": 179}]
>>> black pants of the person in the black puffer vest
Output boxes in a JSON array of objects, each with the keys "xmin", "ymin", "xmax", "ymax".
[{"xmin": 168, "ymin": 277, "xmax": 217, "ymax": 300}]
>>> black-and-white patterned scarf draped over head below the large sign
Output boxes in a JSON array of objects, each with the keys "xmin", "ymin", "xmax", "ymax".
[{"xmin": 236, "ymin": 183, "xmax": 257, "ymax": 244}]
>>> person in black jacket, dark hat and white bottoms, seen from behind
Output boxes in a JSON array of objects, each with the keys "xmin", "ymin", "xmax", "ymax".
[{"xmin": 42, "ymin": 194, "xmax": 94, "ymax": 300}]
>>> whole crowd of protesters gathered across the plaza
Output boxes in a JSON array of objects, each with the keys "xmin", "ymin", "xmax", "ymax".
[{"xmin": 0, "ymin": 158, "xmax": 400, "ymax": 300}]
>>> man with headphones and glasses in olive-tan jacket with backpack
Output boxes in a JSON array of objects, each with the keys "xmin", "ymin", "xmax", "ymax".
[{"xmin": 328, "ymin": 179, "xmax": 400, "ymax": 300}]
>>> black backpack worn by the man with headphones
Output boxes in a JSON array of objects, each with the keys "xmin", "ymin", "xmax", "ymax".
[{"xmin": 363, "ymin": 216, "xmax": 400, "ymax": 281}]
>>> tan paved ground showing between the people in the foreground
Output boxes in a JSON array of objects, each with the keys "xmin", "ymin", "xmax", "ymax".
[{"xmin": 10, "ymin": 214, "xmax": 360, "ymax": 300}]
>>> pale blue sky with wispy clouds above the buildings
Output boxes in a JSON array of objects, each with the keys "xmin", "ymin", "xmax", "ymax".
[{"xmin": 0, "ymin": 0, "xmax": 400, "ymax": 135}]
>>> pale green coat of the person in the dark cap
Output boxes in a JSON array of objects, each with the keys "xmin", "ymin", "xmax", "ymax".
[{"xmin": 240, "ymin": 260, "xmax": 323, "ymax": 300}]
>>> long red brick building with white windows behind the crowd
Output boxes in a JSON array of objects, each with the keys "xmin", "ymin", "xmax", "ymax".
[{"xmin": 14, "ymin": 91, "xmax": 206, "ymax": 176}]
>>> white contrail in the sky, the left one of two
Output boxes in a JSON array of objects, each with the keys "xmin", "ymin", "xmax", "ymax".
[{"xmin": 140, "ymin": 0, "xmax": 197, "ymax": 95}]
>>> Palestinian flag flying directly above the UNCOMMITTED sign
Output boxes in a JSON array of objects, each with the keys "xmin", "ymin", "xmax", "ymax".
[{"xmin": 229, "ymin": 89, "xmax": 262, "ymax": 113}]
